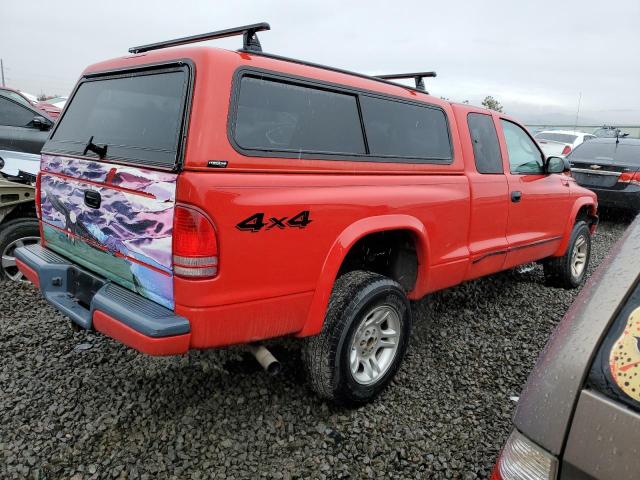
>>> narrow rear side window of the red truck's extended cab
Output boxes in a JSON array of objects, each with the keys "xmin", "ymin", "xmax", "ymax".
[{"xmin": 467, "ymin": 113, "xmax": 504, "ymax": 174}]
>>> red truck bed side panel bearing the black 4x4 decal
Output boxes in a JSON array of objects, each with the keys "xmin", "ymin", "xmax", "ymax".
[{"xmin": 174, "ymin": 171, "xmax": 469, "ymax": 347}]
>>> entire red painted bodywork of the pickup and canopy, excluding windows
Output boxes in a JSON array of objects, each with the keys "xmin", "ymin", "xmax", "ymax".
[{"xmin": 38, "ymin": 47, "xmax": 595, "ymax": 353}]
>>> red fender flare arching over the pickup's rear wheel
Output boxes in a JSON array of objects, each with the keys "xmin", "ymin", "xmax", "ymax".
[{"xmin": 296, "ymin": 215, "xmax": 429, "ymax": 337}]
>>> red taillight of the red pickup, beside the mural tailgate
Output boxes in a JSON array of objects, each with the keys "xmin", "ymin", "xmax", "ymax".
[{"xmin": 173, "ymin": 205, "xmax": 218, "ymax": 278}]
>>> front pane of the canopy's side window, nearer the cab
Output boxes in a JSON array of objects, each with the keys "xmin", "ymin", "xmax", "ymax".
[{"xmin": 361, "ymin": 96, "xmax": 452, "ymax": 161}]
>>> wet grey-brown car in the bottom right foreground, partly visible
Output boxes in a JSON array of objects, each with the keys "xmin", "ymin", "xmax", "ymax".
[{"xmin": 491, "ymin": 220, "xmax": 640, "ymax": 480}]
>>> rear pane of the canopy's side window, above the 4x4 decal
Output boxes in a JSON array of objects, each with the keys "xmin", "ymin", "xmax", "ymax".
[{"xmin": 235, "ymin": 76, "xmax": 365, "ymax": 154}]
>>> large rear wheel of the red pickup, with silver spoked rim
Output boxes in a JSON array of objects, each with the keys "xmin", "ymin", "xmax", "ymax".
[{"xmin": 303, "ymin": 271, "xmax": 411, "ymax": 405}]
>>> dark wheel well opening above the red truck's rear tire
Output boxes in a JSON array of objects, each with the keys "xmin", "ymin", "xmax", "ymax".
[{"xmin": 338, "ymin": 230, "xmax": 418, "ymax": 292}]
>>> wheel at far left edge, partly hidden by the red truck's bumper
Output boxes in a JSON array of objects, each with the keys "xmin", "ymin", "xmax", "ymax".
[{"xmin": 0, "ymin": 218, "xmax": 40, "ymax": 282}]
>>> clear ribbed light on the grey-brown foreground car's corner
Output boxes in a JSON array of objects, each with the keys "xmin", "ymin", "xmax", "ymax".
[{"xmin": 491, "ymin": 430, "xmax": 558, "ymax": 480}]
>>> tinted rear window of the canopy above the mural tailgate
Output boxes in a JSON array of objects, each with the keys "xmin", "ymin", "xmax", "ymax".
[{"xmin": 43, "ymin": 69, "xmax": 188, "ymax": 167}]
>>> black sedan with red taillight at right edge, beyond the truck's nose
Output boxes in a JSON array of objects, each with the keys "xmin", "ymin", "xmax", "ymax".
[{"xmin": 567, "ymin": 138, "xmax": 640, "ymax": 213}]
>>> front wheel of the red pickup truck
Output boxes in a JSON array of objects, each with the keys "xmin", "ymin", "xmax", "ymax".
[{"xmin": 544, "ymin": 221, "xmax": 591, "ymax": 289}]
